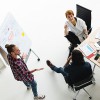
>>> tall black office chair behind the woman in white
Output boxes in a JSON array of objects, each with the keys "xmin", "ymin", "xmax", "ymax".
[{"xmin": 76, "ymin": 4, "xmax": 92, "ymax": 34}]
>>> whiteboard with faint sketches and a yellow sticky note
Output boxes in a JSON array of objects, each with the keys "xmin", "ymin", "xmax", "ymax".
[{"xmin": 0, "ymin": 13, "xmax": 32, "ymax": 56}]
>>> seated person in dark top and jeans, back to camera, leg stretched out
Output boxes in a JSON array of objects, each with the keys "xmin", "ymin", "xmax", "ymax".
[{"xmin": 46, "ymin": 50, "xmax": 92, "ymax": 85}]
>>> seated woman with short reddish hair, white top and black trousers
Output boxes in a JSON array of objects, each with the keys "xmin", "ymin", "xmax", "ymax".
[{"xmin": 64, "ymin": 10, "xmax": 88, "ymax": 56}]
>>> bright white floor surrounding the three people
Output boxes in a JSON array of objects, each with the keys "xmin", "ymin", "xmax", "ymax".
[{"xmin": 0, "ymin": 0, "xmax": 100, "ymax": 100}]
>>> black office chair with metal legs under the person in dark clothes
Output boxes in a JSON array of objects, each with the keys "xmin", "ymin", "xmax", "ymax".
[{"xmin": 69, "ymin": 75, "xmax": 95, "ymax": 100}]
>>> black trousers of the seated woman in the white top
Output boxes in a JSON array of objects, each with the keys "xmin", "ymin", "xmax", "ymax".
[{"xmin": 65, "ymin": 31, "xmax": 81, "ymax": 57}]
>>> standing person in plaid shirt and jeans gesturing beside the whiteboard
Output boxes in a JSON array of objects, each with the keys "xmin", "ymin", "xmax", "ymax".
[{"xmin": 5, "ymin": 44, "xmax": 45, "ymax": 100}]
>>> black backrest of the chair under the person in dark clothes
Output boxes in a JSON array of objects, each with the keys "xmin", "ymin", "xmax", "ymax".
[{"xmin": 72, "ymin": 75, "xmax": 93, "ymax": 91}]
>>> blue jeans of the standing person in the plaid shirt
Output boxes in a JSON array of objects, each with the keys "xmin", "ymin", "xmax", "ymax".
[{"xmin": 23, "ymin": 79, "xmax": 38, "ymax": 96}]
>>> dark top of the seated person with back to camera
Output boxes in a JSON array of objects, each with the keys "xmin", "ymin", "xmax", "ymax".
[{"xmin": 64, "ymin": 62, "xmax": 92, "ymax": 85}]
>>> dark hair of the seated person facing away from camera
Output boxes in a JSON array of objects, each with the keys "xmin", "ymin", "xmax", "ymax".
[{"xmin": 72, "ymin": 50, "xmax": 85, "ymax": 65}]
